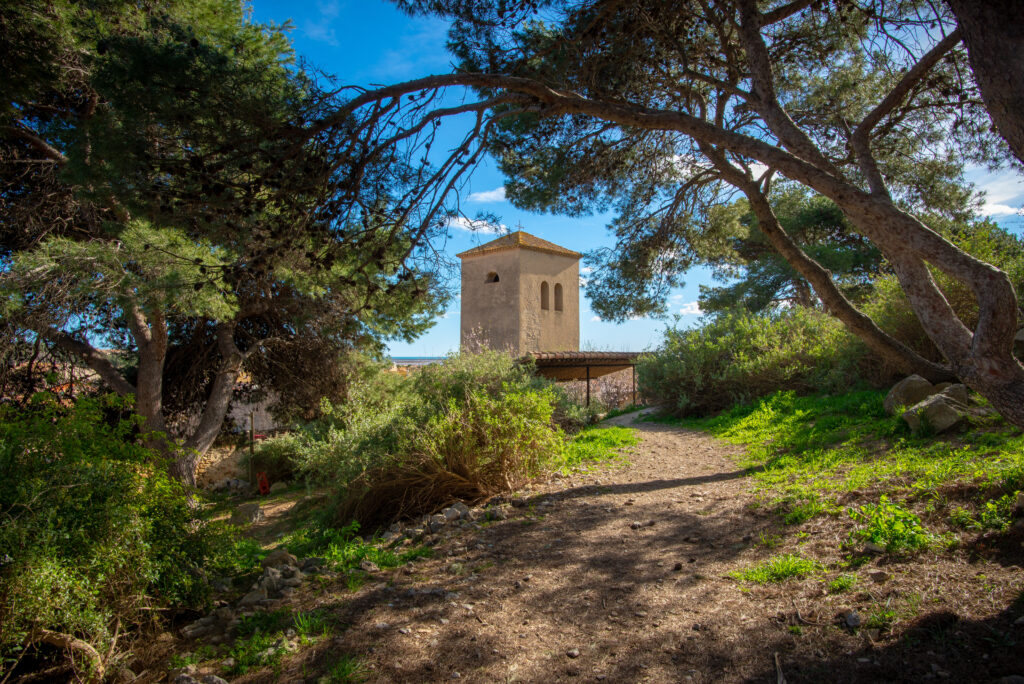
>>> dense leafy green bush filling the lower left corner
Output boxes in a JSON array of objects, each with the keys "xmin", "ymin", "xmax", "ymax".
[{"xmin": 0, "ymin": 395, "xmax": 222, "ymax": 671}]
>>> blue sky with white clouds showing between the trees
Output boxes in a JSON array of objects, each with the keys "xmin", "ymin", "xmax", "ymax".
[{"xmin": 252, "ymin": 0, "xmax": 1024, "ymax": 356}]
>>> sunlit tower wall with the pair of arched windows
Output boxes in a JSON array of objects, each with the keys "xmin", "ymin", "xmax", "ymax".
[{"xmin": 518, "ymin": 250, "xmax": 580, "ymax": 352}]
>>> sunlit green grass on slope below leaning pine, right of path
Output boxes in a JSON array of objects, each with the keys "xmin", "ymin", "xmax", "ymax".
[{"xmin": 655, "ymin": 391, "xmax": 1024, "ymax": 528}]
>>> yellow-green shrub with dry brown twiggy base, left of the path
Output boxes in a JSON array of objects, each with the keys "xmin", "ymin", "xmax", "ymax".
[{"xmin": 339, "ymin": 388, "xmax": 563, "ymax": 528}]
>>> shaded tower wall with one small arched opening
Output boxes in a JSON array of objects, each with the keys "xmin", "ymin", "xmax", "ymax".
[{"xmin": 460, "ymin": 250, "xmax": 520, "ymax": 353}]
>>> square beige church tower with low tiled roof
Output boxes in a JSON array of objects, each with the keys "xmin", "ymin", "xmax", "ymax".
[{"xmin": 457, "ymin": 230, "xmax": 581, "ymax": 356}]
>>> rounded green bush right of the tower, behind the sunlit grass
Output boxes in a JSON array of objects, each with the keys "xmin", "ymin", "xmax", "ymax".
[{"xmin": 637, "ymin": 309, "xmax": 872, "ymax": 416}]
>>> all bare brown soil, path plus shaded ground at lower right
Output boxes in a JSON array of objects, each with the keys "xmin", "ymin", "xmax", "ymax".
[{"xmin": 197, "ymin": 415, "xmax": 1024, "ymax": 682}]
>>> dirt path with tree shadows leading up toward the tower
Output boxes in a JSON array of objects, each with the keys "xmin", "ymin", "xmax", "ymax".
[{"xmin": 258, "ymin": 416, "xmax": 798, "ymax": 682}]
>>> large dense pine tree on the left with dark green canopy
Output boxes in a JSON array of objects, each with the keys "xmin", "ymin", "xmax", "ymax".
[{"xmin": 0, "ymin": 0, "xmax": 444, "ymax": 479}]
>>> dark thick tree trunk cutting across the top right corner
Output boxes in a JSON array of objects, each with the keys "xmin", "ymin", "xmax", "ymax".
[{"xmin": 947, "ymin": 0, "xmax": 1024, "ymax": 163}]
